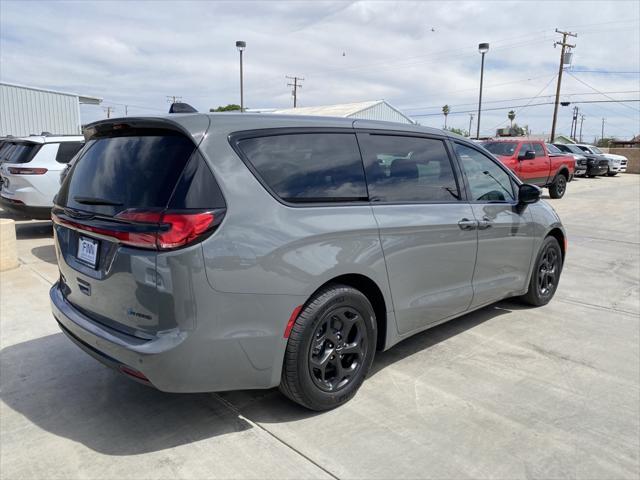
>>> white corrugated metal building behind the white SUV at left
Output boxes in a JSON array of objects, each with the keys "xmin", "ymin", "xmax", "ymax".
[{"xmin": 0, "ymin": 82, "xmax": 102, "ymax": 137}]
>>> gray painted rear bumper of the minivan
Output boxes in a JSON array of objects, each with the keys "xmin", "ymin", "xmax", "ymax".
[{"xmin": 49, "ymin": 283, "xmax": 286, "ymax": 393}]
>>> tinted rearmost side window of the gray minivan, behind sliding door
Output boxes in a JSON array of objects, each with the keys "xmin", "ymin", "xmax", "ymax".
[{"xmin": 238, "ymin": 133, "xmax": 367, "ymax": 202}]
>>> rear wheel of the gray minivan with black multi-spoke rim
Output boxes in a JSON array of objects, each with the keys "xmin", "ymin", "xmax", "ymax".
[{"xmin": 280, "ymin": 284, "xmax": 377, "ymax": 411}]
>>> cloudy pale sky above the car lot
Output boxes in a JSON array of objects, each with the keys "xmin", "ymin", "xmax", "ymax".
[{"xmin": 0, "ymin": 0, "xmax": 640, "ymax": 141}]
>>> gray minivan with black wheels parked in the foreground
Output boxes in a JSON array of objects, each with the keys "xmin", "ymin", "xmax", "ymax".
[{"xmin": 50, "ymin": 113, "xmax": 566, "ymax": 410}]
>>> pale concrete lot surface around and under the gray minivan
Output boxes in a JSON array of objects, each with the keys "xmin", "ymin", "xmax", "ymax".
[{"xmin": 0, "ymin": 175, "xmax": 640, "ymax": 479}]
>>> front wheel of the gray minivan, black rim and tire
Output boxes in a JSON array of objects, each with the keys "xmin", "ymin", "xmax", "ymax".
[{"xmin": 520, "ymin": 236, "xmax": 563, "ymax": 307}]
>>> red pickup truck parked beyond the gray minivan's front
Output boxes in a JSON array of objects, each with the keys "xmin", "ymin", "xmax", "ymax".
[{"xmin": 483, "ymin": 138, "xmax": 576, "ymax": 198}]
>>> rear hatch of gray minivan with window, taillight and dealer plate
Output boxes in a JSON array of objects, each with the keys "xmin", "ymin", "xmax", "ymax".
[{"xmin": 52, "ymin": 120, "xmax": 225, "ymax": 339}]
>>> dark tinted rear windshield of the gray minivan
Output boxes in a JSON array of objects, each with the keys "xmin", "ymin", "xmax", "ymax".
[{"xmin": 57, "ymin": 132, "xmax": 195, "ymax": 215}]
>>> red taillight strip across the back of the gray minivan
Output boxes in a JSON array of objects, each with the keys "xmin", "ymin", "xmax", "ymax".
[{"xmin": 52, "ymin": 210, "xmax": 224, "ymax": 250}]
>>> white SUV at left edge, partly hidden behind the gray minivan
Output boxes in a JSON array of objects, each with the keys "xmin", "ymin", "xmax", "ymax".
[{"xmin": 0, "ymin": 135, "xmax": 84, "ymax": 219}]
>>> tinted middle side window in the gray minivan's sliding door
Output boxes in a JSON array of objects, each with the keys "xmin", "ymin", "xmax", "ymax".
[{"xmin": 358, "ymin": 134, "xmax": 460, "ymax": 202}]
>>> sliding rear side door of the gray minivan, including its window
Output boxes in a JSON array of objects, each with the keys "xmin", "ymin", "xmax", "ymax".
[{"xmin": 358, "ymin": 131, "xmax": 477, "ymax": 334}]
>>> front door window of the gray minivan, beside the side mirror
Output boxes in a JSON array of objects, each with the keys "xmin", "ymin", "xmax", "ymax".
[{"xmin": 455, "ymin": 143, "xmax": 515, "ymax": 202}]
